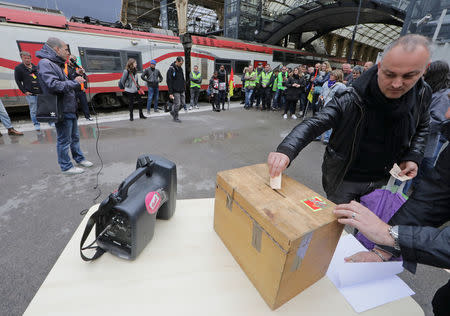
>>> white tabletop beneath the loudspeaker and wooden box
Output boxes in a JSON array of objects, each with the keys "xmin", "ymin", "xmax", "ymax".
[{"xmin": 24, "ymin": 199, "xmax": 423, "ymax": 316}]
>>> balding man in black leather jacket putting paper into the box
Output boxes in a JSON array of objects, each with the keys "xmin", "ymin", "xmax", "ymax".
[{"xmin": 268, "ymin": 34, "xmax": 431, "ymax": 204}]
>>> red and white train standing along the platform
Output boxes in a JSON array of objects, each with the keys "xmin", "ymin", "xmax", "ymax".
[{"xmin": 0, "ymin": 5, "xmax": 352, "ymax": 107}]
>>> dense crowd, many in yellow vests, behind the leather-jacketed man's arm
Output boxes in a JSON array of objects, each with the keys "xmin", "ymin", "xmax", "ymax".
[{"xmin": 241, "ymin": 61, "xmax": 373, "ymax": 123}]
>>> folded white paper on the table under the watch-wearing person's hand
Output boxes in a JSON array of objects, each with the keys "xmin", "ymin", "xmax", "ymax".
[{"xmin": 327, "ymin": 235, "xmax": 414, "ymax": 313}]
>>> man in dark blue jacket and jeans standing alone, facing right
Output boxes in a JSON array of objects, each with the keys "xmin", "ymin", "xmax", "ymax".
[{"xmin": 36, "ymin": 37, "xmax": 93, "ymax": 174}]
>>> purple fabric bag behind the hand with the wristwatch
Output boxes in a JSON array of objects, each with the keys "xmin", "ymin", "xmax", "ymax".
[{"xmin": 355, "ymin": 177, "xmax": 408, "ymax": 250}]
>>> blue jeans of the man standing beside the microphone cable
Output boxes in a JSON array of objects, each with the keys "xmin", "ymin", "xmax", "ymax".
[{"xmin": 55, "ymin": 118, "xmax": 84, "ymax": 171}]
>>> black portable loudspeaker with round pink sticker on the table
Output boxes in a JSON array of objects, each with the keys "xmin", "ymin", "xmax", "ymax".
[{"xmin": 80, "ymin": 155, "xmax": 177, "ymax": 261}]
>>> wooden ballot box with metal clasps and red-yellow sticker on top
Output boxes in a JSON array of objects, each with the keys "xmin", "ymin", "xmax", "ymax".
[{"xmin": 214, "ymin": 164, "xmax": 343, "ymax": 309}]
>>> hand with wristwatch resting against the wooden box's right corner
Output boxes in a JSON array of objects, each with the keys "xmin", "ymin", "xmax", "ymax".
[{"xmin": 334, "ymin": 201, "xmax": 394, "ymax": 247}]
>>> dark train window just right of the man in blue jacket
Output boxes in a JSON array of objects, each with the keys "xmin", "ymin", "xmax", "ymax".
[{"xmin": 80, "ymin": 47, "xmax": 124, "ymax": 72}]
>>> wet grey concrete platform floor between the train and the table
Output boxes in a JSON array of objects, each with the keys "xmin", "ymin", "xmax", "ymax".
[{"xmin": 0, "ymin": 103, "xmax": 449, "ymax": 315}]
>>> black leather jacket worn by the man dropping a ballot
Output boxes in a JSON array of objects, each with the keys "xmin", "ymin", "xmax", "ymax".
[{"xmin": 277, "ymin": 76, "xmax": 431, "ymax": 195}]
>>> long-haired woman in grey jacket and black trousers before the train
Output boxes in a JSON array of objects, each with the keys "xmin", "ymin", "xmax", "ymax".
[{"xmin": 120, "ymin": 58, "xmax": 146, "ymax": 121}]
